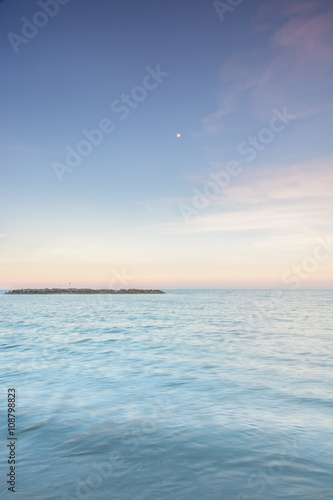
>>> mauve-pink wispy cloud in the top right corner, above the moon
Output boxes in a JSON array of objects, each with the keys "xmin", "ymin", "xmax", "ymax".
[{"xmin": 201, "ymin": 1, "xmax": 333, "ymax": 135}]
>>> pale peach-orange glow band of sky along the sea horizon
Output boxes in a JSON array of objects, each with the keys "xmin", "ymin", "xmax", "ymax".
[{"xmin": 0, "ymin": 256, "xmax": 332, "ymax": 290}]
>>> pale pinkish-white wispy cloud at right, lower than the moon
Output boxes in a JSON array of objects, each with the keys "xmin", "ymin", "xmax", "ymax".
[{"xmin": 155, "ymin": 160, "xmax": 333, "ymax": 242}]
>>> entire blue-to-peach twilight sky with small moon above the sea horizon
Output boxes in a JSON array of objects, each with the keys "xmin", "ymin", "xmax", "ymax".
[{"xmin": 0, "ymin": 0, "xmax": 333, "ymax": 289}]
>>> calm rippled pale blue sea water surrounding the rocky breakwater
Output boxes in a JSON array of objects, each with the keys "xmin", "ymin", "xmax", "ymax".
[{"xmin": 0, "ymin": 290, "xmax": 333, "ymax": 500}]
